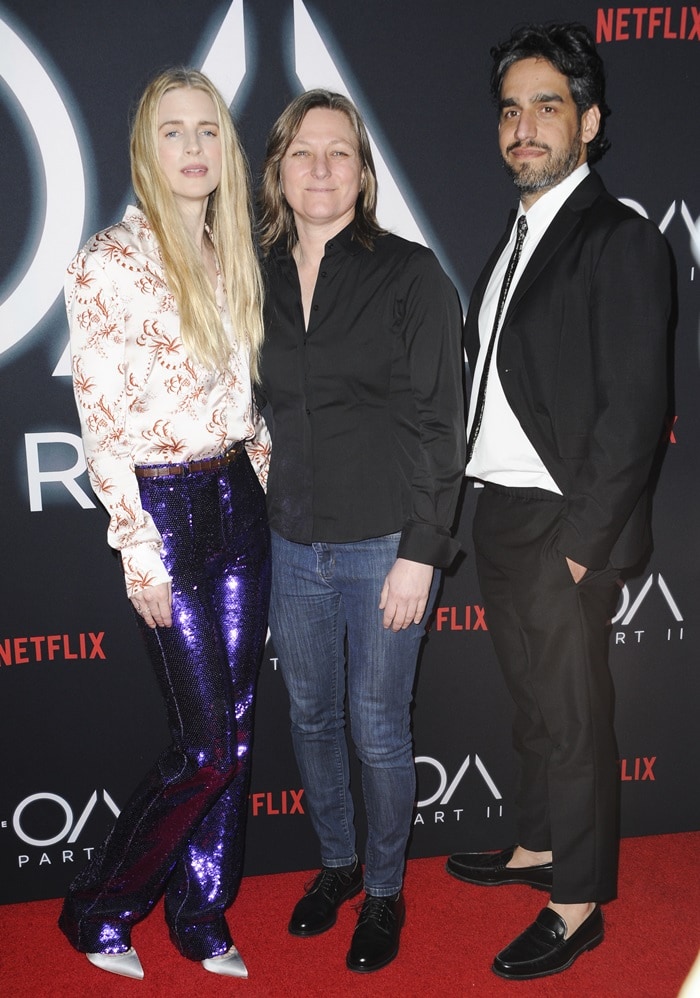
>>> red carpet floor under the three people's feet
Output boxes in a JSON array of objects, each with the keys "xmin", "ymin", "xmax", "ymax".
[{"xmin": 0, "ymin": 832, "xmax": 700, "ymax": 998}]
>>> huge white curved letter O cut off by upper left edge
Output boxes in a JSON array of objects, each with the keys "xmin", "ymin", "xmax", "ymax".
[{"xmin": 0, "ymin": 21, "xmax": 85, "ymax": 354}]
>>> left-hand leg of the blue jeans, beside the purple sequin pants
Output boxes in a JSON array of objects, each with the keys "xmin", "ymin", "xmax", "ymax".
[{"xmin": 270, "ymin": 532, "xmax": 355, "ymax": 867}]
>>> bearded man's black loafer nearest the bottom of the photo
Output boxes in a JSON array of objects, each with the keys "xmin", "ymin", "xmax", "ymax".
[{"xmin": 491, "ymin": 907, "xmax": 604, "ymax": 981}]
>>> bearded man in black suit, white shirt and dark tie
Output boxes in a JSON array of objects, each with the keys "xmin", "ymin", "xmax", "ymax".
[{"xmin": 447, "ymin": 24, "xmax": 671, "ymax": 979}]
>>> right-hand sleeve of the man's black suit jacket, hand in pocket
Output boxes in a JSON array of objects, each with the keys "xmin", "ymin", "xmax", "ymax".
[{"xmin": 558, "ymin": 216, "xmax": 671, "ymax": 569}]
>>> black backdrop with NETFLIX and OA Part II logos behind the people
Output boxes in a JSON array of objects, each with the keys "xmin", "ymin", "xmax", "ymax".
[{"xmin": 0, "ymin": 0, "xmax": 700, "ymax": 902}]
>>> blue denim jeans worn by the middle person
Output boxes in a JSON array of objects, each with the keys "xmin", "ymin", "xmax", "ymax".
[{"xmin": 270, "ymin": 533, "xmax": 440, "ymax": 897}]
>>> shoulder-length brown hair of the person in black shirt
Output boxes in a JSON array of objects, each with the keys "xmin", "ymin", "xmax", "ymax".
[{"xmin": 259, "ymin": 90, "xmax": 385, "ymax": 253}]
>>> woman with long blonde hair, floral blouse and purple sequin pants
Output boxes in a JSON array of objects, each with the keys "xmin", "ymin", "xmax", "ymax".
[{"xmin": 59, "ymin": 69, "xmax": 270, "ymax": 978}]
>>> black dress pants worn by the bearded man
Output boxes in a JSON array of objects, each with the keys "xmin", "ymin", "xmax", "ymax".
[{"xmin": 474, "ymin": 486, "xmax": 620, "ymax": 904}]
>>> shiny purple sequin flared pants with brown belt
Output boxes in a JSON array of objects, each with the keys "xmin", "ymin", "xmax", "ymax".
[{"xmin": 59, "ymin": 452, "xmax": 270, "ymax": 960}]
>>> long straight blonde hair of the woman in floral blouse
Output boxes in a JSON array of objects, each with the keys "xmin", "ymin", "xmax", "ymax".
[{"xmin": 130, "ymin": 68, "xmax": 263, "ymax": 380}]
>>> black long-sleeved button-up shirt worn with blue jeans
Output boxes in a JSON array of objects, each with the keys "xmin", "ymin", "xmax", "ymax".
[{"xmin": 262, "ymin": 225, "xmax": 465, "ymax": 566}]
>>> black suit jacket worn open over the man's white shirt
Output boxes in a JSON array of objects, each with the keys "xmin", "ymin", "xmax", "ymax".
[{"xmin": 465, "ymin": 172, "xmax": 672, "ymax": 569}]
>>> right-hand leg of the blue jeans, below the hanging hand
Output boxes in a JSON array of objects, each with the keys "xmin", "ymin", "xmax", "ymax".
[{"xmin": 334, "ymin": 534, "xmax": 440, "ymax": 897}]
